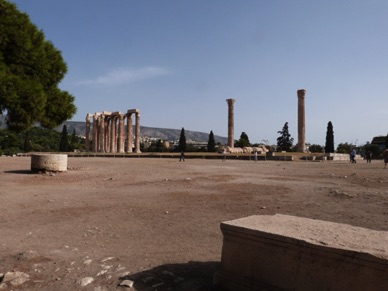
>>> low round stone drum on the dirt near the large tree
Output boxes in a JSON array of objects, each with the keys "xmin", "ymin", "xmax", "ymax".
[{"xmin": 31, "ymin": 154, "xmax": 67, "ymax": 172}]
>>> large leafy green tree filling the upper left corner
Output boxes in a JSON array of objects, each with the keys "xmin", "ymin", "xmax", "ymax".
[{"xmin": 0, "ymin": 0, "xmax": 76, "ymax": 131}]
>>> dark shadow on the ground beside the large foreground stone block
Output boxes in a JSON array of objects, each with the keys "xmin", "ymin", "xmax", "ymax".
[{"xmin": 120, "ymin": 262, "xmax": 224, "ymax": 291}]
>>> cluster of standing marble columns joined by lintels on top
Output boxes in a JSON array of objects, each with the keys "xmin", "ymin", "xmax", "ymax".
[{"xmin": 85, "ymin": 109, "xmax": 140, "ymax": 153}]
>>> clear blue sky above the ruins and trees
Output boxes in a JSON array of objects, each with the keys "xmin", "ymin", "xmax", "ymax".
[{"xmin": 11, "ymin": 0, "xmax": 388, "ymax": 146}]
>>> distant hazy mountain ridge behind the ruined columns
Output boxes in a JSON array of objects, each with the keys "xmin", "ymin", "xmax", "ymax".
[{"xmin": 54, "ymin": 121, "xmax": 228, "ymax": 144}]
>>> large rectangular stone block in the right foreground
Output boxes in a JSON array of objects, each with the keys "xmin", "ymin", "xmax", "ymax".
[{"xmin": 214, "ymin": 215, "xmax": 388, "ymax": 291}]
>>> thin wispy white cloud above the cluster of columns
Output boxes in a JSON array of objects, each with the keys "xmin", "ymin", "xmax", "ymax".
[{"xmin": 78, "ymin": 67, "xmax": 170, "ymax": 86}]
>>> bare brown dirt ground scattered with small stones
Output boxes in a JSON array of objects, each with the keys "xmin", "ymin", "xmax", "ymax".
[{"xmin": 0, "ymin": 157, "xmax": 388, "ymax": 291}]
